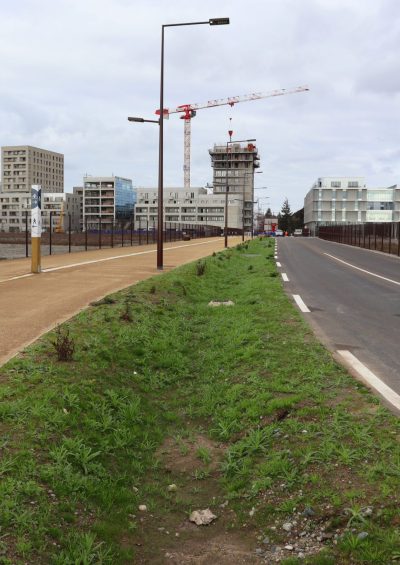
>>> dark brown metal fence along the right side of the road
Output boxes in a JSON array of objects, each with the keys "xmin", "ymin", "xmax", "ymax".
[{"xmin": 318, "ymin": 222, "xmax": 400, "ymax": 256}]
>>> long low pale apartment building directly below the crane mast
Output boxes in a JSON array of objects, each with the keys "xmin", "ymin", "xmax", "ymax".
[{"xmin": 135, "ymin": 187, "xmax": 242, "ymax": 229}]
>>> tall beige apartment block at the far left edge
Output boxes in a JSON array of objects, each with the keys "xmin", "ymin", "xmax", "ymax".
[{"xmin": 1, "ymin": 145, "xmax": 64, "ymax": 193}]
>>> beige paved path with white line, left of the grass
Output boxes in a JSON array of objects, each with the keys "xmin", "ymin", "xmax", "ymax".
[{"xmin": 0, "ymin": 237, "xmax": 241, "ymax": 365}]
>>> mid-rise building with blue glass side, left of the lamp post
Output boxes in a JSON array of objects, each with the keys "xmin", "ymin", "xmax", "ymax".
[{"xmin": 82, "ymin": 176, "xmax": 136, "ymax": 230}]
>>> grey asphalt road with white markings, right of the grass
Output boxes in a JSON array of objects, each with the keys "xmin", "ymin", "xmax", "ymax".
[{"xmin": 277, "ymin": 237, "xmax": 400, "ymax": 394}]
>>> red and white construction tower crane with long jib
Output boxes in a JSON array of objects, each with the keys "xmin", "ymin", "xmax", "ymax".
[{"xmin": 156, "ymin": 86, "xmax": 310, "ymax": 188}]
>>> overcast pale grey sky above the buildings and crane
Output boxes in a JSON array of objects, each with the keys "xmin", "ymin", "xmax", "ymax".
[{"xmin": 0, "ymin": 0, "xmax": 400, "ymax": 211}]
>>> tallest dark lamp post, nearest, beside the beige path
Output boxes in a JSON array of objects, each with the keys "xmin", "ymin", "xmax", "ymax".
[{"xmin": 157, "ymin": 18, "xmax": 229, "ymax": 270}]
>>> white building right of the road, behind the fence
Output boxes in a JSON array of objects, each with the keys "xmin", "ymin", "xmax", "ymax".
[{"xmin": 304, "ymin": 177, "xmax": 400, "ymax": 233}]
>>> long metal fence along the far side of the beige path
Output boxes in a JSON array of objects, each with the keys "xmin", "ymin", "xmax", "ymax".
[{"xmin": 0, "ymin": 215, "xmax": 221, "ymax": 257}]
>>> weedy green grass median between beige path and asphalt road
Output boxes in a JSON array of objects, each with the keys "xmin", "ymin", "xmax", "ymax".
[{"xmin": 0, "ymin": 240, "xmax": 400, "ymax": 565}]
